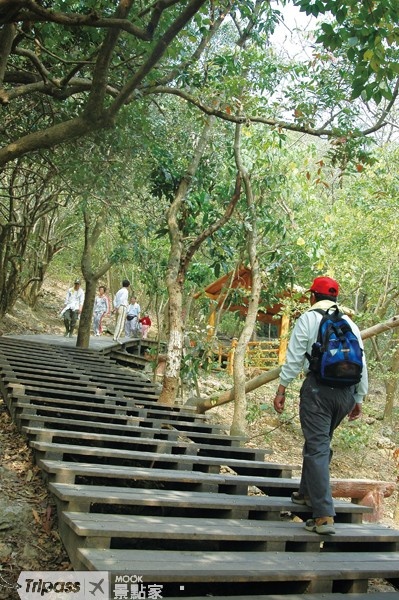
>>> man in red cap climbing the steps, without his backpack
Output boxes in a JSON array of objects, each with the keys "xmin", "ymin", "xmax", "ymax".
[{"xmin": 274, "ymin": 277, "xmax": 368, "ymax": 535}]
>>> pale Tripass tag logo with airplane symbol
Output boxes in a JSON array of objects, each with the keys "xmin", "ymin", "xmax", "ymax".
[{"xmin": 18, "ymin": 571, "xmax": 109, "ymax": 600}]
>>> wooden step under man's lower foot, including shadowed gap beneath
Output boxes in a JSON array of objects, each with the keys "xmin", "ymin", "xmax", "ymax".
[{"xmin": 60, "ymin": 511, "xmax": 399, "ymax": 556}]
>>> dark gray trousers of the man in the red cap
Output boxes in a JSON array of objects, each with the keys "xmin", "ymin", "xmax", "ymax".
[{"xmin": 299, "ymin": 373, "xmax": 355, "ymax": 518}]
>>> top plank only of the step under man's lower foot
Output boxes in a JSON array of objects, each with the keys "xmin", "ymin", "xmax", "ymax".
[{"xmin": 62, "ymin": 511, "xmax": 399, "ymax": 552}]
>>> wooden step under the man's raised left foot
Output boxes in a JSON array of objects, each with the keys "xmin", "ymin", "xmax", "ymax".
[{"xmin": 49, "ymin": 483, "xmax": 374, "ymax": 523}]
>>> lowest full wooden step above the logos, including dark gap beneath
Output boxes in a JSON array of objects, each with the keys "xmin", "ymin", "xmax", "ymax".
[{"xmin": 75, "ymin": 548, "xmax": 399, "ymax": 596}]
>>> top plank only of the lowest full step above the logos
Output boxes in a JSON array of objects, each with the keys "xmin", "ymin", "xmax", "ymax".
[{"xmin": 78, "ymin": 548, "xmax": 399, "ymax": 583}]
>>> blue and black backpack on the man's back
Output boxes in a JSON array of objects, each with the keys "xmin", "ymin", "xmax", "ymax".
[{"xmin": 306, "ymin": 305, "xmax": 363, "ymax": 387}]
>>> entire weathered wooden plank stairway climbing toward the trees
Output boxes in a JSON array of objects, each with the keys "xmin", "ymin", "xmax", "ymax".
[{"xmin": 0, "ymin": 337, "xmax": 399, "ymax": 600}]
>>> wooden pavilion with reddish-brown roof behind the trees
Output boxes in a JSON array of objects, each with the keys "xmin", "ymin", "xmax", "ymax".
[{"xmin": 194, "ymin": 266, "xmax": 308, "ymax": 372}]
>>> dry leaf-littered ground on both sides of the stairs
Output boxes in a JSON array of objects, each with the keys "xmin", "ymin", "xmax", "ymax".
[{"xmin": 0, "ymin": 282, "xmax": 399, "ymax": 600}]
